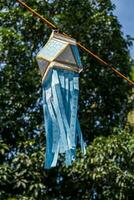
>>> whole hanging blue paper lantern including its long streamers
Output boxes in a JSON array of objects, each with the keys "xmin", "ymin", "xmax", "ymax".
[{"xmin": 37, "ymin": 31, "xmax": 85, "ymax": 168}]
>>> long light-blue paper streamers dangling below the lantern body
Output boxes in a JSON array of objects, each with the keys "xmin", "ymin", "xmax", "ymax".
[{"xmin": 43, "ymin": 68, "xmax": 85, "ymax": 168}]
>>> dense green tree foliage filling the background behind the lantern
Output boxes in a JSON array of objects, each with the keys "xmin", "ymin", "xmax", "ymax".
[{"xmin": 0, "ymin": 0, "xmax": 134, "ymax": 200}]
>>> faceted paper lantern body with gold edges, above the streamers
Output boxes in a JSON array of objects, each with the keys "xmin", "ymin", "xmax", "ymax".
[{"xmin": 36, "ymin": 31, "xmax": 82, "ymax": 75}]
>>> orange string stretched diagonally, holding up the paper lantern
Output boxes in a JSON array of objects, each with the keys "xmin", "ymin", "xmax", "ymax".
[{"xmin": 16, "ymin": 0, "xmax": 134, "ymax": 85}]
